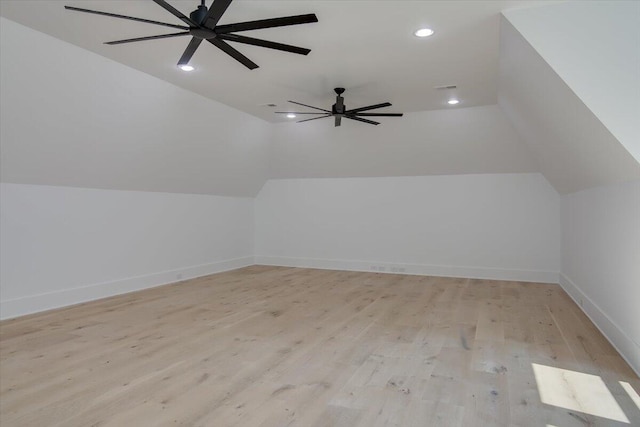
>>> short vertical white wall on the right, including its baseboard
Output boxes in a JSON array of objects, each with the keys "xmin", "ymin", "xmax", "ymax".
[{"xmin": 561, "ymin": 181, "xmax": 640, "ymax": 372}]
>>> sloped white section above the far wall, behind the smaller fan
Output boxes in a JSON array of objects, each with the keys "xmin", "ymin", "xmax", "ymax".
[{"xmin": 270, "ymin": 105, "xmax": 538, "ymax": 178}]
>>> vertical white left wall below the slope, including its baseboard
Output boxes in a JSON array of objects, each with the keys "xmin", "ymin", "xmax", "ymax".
[{"xmin": 0, "ymin": 184, "xmax": 254, "ymax": 318}]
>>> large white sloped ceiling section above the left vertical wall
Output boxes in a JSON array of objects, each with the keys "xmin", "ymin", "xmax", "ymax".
[{"xmin": 0, "ymin": 16, "xmax": 270, "ymax": 197}]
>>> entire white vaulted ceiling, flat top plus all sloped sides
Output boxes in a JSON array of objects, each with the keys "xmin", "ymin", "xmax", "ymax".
[{"xmin": 0, "ymin": 0, "xmax": 640, "ymax": 196}]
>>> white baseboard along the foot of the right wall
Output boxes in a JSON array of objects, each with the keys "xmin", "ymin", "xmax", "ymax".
[{"xmin": 560, "ymin": 274, "xmax": 640, "ymax": 376}]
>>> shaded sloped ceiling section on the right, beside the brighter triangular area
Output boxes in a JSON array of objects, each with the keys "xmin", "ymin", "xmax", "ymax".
[{"xmin": 498, "ymin": 6, "xmax": 640, "ymax": 194}]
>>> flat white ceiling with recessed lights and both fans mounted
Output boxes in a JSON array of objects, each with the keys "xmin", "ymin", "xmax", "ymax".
[{"xmin": 0, "ymin": 0, "xmax": 549, "ymax": 122}]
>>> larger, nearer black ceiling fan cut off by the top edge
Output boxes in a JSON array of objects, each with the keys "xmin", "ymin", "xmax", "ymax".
[{"xmin": 65, "ymin": 0, "xmax": 318, "ymax": 70}]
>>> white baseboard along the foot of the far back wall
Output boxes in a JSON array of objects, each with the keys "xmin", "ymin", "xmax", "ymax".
[{"xmin": 255, "ymin": 256, "xmax": 558, "ymax": 284}]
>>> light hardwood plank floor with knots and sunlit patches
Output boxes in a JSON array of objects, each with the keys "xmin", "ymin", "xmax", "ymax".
[{"xmin": 0, "ymin": 266, "xmax": 640, "ymax": 427}]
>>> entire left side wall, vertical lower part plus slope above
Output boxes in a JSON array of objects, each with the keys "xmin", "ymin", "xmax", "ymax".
[{"xmin": 0, "ymin": 18, "xmax": 270, "ymax": 318}]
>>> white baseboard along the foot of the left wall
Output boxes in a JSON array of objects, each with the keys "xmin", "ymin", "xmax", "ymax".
[{"xmin": 0, "ymin": 256, "xmax": 254, "ymax": 320}]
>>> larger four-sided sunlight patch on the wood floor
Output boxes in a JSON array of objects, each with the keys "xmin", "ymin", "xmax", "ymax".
[{"xmin": 531, "ymin": 363, "xmax": 629, "ymax": 424}]
